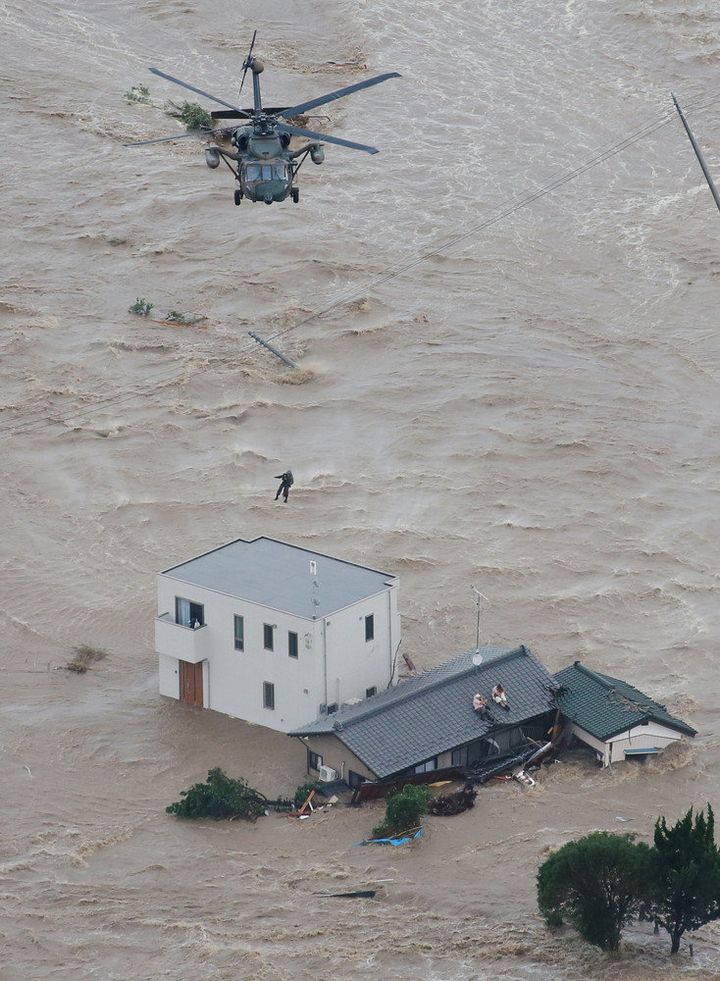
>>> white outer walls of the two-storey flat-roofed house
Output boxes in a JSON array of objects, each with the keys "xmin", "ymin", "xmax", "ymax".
[{"xmin": 157, "ymin": 574, "xmax": 400, "ymax": 732}]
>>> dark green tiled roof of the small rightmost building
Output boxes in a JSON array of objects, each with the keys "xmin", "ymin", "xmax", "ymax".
[{"xmin": 553, "ymin": 661, "xmax": 696, "ymax": 740}]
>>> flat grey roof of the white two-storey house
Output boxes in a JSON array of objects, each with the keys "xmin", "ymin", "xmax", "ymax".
[{"xmin": 161, "ymin": 537, "xmax": 396, "ymax": 620}]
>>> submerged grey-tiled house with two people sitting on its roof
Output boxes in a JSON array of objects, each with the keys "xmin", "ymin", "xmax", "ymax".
[{"xmin": 290, "ymin": 645, "xmax": 556, "ymax": 787}]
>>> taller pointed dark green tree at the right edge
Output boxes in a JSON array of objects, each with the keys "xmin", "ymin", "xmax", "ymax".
[{"xmin": 650, "ymin": 804, "xmax": 720, "ymax": 954}]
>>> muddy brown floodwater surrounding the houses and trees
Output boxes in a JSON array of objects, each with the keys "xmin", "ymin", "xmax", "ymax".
[{"xmin": 0, "ymin": 0, "xmax": 720, "ymax": 981}]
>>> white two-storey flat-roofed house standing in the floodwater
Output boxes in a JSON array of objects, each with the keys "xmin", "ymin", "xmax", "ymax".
[{"xmin": 155, "ymin": 538, "xmax": 400, "ymax": 732}]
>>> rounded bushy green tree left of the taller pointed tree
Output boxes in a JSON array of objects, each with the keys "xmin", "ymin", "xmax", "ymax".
[{"xmin": 537, "ymin": 831, "xmax": 652, "ymax": 950}]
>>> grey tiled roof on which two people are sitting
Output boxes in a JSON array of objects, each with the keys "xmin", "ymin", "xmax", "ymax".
[{"xmin": 291, "ymin": 645, "xmax": 554, "ymax": 779}]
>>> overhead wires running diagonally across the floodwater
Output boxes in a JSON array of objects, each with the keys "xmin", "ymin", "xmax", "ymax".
[{"xmin": 0, "ymin": 90, "xmax": 718, "ymax": 439}]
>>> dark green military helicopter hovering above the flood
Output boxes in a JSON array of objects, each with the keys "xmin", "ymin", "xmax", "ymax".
[{"xmin": 125, "ymin": 31, "xmax": 400, "ymax": 205}]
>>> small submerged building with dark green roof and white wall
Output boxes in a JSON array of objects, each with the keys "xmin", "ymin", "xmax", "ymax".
[{"xmin": 554, "ymin": 661, "xmax": 696, "ymax": 766}]
